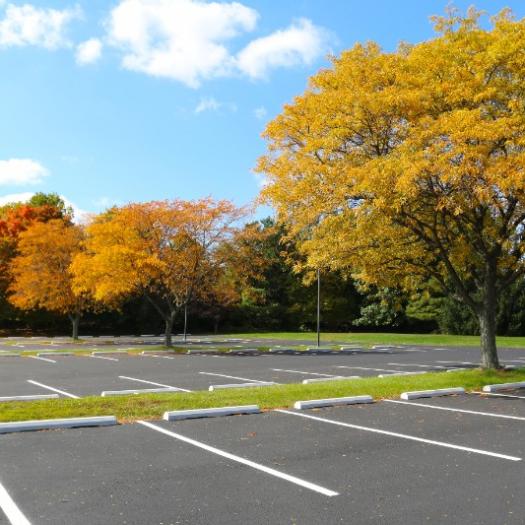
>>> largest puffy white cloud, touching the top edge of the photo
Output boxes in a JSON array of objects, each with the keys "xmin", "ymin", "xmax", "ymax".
[{"xmin": 107, "ymin": 0, "xmax": 258, "ymax": 87}]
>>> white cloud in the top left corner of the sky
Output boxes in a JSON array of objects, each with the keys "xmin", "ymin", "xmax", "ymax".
[{"xmin": 0, "ymin": 4, "xmax": 82, "ymax": 49}]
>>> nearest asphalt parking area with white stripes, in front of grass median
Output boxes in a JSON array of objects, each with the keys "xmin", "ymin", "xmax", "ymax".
[{"xmin": 0, "ymin": 396, "xmax": 525, "ymax": 525}]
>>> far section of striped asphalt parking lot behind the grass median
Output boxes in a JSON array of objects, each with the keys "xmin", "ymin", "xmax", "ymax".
[{"xmin": 0, "ymin": 340, "xmax": 525, "ymax": 398}]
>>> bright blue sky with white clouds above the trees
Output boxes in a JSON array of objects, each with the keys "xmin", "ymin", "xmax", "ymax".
[{"xmin": 0, "ymin": 0, "xmax": 525, "ymax": 219}]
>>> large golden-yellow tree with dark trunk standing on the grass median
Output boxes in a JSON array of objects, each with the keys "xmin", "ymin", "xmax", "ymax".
[{"xmin": 258, "ymin": 9, "xmax": 525, "ymax": 368}]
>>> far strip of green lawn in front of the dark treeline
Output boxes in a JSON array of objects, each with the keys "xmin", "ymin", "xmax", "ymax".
[{"xmin": 229, "ymin": 332, "xmax": 525, "ymax": 348}]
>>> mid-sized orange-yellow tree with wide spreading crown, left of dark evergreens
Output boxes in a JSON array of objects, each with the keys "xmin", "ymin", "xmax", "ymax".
[{"xmin": 72, "ymin": 199, "xmax": 244, "ymax": 346}]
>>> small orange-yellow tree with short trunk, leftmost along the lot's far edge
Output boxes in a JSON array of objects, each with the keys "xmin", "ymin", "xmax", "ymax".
[{"xmin": 9, "ymin": 219, "xmax": 90, "ymax": 339}]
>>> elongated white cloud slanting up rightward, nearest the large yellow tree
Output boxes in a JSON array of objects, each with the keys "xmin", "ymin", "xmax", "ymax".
[{"xmin": 237, "ymin": 18, "xmax": 327, "ymax": 78}]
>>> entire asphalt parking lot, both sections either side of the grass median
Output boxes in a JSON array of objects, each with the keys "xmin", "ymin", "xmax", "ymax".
[{"xmin": 0, "ymin": 338, "xmax": 525, "ymax": 525}]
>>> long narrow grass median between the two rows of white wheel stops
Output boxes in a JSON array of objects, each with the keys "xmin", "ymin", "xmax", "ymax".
[{"xmin": 0, "ymin": 368, "xmax": 525, "ymax": 422}]
